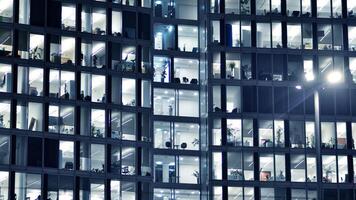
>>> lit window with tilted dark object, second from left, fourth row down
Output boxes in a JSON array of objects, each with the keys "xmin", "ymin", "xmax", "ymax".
[{"xmin": 16, "ymin": 102, "xmax": 43, "ymax": 131}]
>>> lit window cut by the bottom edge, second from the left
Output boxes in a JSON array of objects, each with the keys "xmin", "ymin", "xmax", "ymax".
[{"xmin": 15, "ymin": 172, "xmax": 42, "ymax": 200}]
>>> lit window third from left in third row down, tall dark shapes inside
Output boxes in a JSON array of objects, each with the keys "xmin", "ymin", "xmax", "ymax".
[{"xmin": 49, "ymin": 69, "xmax": 76, "ymax": 99}]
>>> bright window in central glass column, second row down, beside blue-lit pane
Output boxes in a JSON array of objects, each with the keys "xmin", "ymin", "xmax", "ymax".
[{"xmin": 178, "ymin": 25, "xmax": 199, "ymax": 53}]
